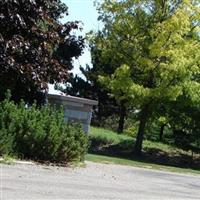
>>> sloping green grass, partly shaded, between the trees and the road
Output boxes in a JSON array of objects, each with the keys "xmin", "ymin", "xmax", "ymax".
[{"xmin": 86, "ymin": 127, "xmax": 200, "ymax": 174}]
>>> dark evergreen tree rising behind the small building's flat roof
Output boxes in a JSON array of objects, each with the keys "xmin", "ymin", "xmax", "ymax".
[{"xmin": 60, "ymin": 32, "xmax": 126, "ymax": 133}]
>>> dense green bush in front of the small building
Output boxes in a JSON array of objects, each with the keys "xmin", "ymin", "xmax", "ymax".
[{"xmin": 0, "ymin": 94, "xmax": 87, "ymax": 163}]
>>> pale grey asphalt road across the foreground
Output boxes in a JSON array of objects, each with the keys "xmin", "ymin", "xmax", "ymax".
[{"xmin": 0, "ymin": 162, "xmax": 200, "ymax": 200}]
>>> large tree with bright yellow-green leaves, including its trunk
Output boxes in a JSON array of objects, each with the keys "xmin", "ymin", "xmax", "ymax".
[{"xmin": 94, "ymin": 0, "xmax": 200, "ymax": 154}]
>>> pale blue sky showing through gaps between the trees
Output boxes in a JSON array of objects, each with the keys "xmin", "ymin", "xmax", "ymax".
[{"xmin": 49, "ymin": 0, "xmax": 100, "ymax": 94}]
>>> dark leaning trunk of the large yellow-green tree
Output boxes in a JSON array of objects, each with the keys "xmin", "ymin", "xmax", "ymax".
[{"xmin": 134, "ymin": 105, "xmax": 149, "ymax": 155}]
